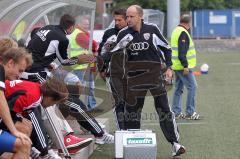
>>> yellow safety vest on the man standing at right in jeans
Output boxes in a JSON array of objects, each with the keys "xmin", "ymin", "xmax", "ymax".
[{"xmin": 171, "ymin": 26, "xmax": 197, "ymax": 70}]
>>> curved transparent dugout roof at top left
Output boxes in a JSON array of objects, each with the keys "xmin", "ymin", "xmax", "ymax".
[{"xmin": 0, "ymin": 0, "xmax": 96, "ymax": 48}]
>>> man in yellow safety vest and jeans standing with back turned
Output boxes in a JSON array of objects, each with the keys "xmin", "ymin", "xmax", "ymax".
[{"xmin": 171, "ymin": 14, "xmax": 200, "ymax": 120}]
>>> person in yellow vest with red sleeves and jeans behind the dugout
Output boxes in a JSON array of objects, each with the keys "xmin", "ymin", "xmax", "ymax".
[{"xmin": 69, "ymin": 17, "xmax": 98, "ymax": 110}]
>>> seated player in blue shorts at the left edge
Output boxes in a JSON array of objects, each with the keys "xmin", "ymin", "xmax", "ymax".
[{"xmin": 0, "ymin": 45, "xmax": 31, "ymax": 159}]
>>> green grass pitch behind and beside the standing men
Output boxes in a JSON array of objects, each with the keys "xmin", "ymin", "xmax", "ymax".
[{"xmin": 90, "ymin": 52, "xmax": 240, "ymax": 159}]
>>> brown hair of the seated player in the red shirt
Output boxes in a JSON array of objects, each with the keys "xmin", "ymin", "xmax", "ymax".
[{"xmin": 41, "ymin": 77, "xmax": 68, "ymax": 101}]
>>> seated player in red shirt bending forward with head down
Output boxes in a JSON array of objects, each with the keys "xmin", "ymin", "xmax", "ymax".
[{"xmin": 5, "ymin": 78, "xmax": 92, "ymax": 158}]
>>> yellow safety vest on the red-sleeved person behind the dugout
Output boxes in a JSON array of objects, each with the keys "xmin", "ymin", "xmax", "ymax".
[{"xmin": 69, "ymin": 28, "xmax": 88, "ymax": 70}]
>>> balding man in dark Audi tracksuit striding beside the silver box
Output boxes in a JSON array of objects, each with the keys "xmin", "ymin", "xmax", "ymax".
[{"xmin": 111, "ymin": 5, "xmax": 186, "ymax": 156}]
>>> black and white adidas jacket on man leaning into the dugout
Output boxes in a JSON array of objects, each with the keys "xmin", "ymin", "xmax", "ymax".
[{"xmin": 27, "ymin": 25, "xmax": 77, "ymax": 72}]
